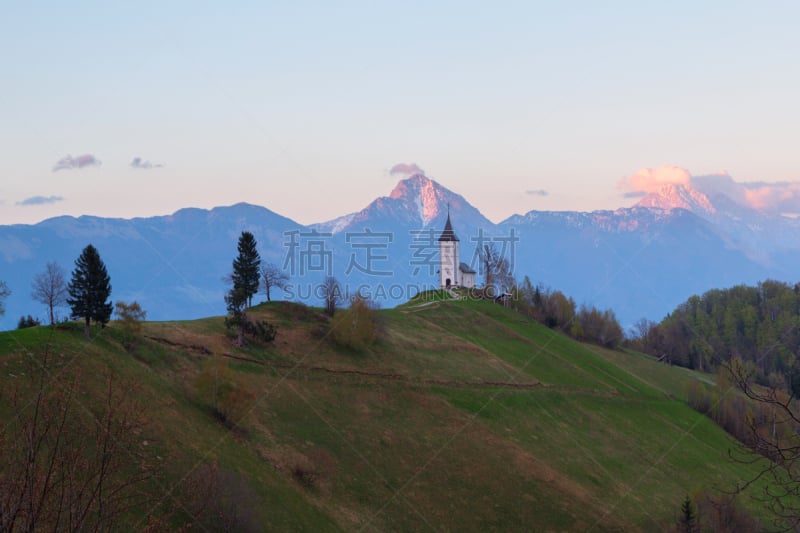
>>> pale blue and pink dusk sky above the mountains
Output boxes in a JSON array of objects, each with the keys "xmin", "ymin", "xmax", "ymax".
[{"xmin": 0, "ymin": 0, "xmax": 800, "ymax": 224}]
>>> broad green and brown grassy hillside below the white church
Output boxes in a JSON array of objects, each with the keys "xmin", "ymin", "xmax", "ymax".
[{"xmin": 0, "ymin": 300, "xmax": 776, "ymax": 531}]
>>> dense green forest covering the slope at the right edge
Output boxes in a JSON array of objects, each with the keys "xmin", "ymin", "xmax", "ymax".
[{"xmin": 638, "ymin": 280, "xmax": 800, "ymax": 385}]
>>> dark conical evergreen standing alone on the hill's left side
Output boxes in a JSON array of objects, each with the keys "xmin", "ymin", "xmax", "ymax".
[{"xmin": 67, "ymin": 244, "xmax": 113, "ymax": 338}]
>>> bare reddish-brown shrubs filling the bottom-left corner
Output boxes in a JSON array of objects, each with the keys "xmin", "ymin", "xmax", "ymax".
[{"xmin": 0, "ymin": 353, "xmax": 160, "ymax": 531}]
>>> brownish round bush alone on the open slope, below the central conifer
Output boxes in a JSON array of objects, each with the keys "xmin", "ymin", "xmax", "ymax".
[{"xmin": 195, "ymin": 357, "xmax": 256, "ymax": 429}]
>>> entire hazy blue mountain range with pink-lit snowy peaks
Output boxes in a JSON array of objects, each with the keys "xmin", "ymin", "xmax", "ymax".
[{"xmin": 0, "ymin": 173, "xmax": 800, "ymax": 329}]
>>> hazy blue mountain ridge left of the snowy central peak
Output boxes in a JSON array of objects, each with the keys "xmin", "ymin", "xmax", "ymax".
[{"xmin": 0, "ymin": 203, "xmax": 302, "ymax": 329}]
